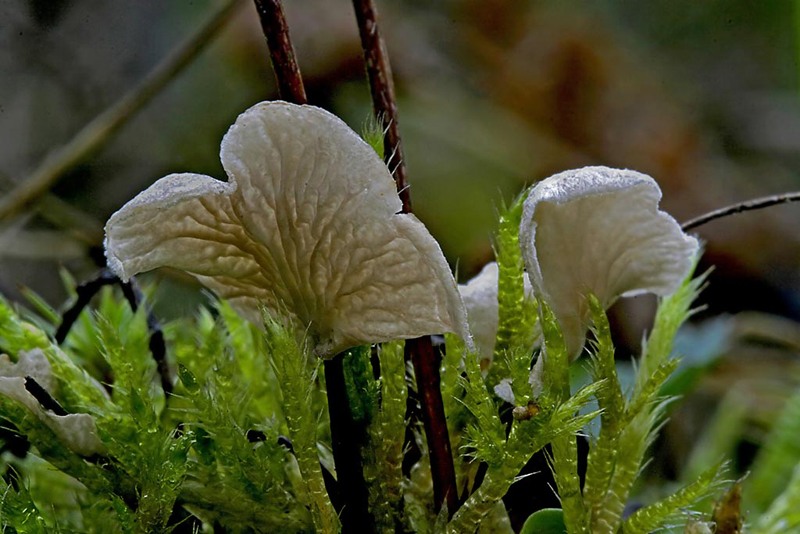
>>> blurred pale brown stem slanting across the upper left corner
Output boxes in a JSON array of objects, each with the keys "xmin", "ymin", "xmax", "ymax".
[{"xmin": 0, "ymin": 0, "xmax": 241, "ymax": 221}]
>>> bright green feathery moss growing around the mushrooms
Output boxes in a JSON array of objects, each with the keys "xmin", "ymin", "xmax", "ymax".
[{"xmin": 0, "ymin": 240, "xmax": 800, "ymax": 532}]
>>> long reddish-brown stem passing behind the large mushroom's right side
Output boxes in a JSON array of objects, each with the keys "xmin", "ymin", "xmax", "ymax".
[{"xmin": 353, "ymin": 0, "xmax": 458, "ymax": 515}]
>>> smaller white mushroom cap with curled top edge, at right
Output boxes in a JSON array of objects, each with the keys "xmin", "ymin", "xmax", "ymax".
[{"xmin": 520, "ymin": 167, "xmax": 698, "ymax": 357}]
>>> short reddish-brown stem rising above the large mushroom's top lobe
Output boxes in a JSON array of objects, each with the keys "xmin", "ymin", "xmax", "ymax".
[{"xmin": 255, "ymin": 0, "xmax": 308, "ymax": 104}]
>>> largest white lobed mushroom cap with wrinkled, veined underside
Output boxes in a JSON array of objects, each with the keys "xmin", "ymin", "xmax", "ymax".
[{"xmin": 105, "ymin": 102, "xmax": 469, "ymax": 357}]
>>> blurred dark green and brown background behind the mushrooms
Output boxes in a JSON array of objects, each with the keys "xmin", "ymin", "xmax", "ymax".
[{"xmin": 0, "ymin": 0, "xmax": 800, "ymax": 498}]
